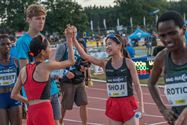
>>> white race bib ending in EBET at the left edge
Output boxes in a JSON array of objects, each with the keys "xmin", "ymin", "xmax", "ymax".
[{"xmin": 0, "ymin": 73, "xmax": 16, "ymax": 86}]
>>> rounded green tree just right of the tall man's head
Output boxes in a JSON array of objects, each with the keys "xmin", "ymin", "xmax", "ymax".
[{"xmin": 45, "ymin": 0, "xmax": 88, "ymax": 33}]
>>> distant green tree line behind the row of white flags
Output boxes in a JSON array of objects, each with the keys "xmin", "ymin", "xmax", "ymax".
[{"xmin": 85, "ymin": 0, "xmax": 169, "ymax": 32}]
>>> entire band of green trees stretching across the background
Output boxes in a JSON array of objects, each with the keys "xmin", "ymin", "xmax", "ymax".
[{"xmin": 0, "ymin": 0, "xmax": 187, "ymax": 34}]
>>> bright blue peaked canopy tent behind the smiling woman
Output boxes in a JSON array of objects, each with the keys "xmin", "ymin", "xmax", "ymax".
[{"xmin": 129, "ymin": 28, "xmax": 151, "ymax": 39}]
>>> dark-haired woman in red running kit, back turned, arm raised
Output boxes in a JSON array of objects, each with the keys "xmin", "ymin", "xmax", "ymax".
[{"xmin": 11, "ymin": 26, "xmax": 74, "ymax": 125}]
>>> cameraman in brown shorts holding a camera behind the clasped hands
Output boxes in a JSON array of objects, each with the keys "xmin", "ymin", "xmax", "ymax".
[{"xmin": 55, "ymin": 35, "xmax": 88, "ymax": 125}]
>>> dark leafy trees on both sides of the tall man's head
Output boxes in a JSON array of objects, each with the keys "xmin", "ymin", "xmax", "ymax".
[{"xmin": 0, "ymin": 0, "xmax": 88, "ymax": 33}]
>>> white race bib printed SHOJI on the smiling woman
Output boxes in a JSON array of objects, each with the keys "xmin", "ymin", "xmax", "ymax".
[{"xmin": 107, "ymin": 82, "xmax": 128, "ymax": 97}]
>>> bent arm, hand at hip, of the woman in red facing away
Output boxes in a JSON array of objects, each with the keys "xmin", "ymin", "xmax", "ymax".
[{"xmin": 11, "ymin": 67, "xmax": 28, "ymax": 103}]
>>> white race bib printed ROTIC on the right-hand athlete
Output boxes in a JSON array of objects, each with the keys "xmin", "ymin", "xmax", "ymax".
[{"xmin": 164, "ymin": 82, "xmax": 187, "ymax": 106}]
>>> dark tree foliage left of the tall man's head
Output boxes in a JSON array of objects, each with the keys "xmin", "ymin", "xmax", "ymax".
[{"xmin": 0, "ymin": 0, "xmax": 37, "ymax": 31}]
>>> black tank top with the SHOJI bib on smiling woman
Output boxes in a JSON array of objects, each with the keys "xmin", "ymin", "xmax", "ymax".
[{"xmin": 105, "ymin": 58, "xmax": 133, "ymax": 97}]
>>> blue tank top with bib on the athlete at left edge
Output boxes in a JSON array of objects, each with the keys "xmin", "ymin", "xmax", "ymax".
[{"xmin": 0, "ymin": 58, "xmax": 17, "ymax": 89}]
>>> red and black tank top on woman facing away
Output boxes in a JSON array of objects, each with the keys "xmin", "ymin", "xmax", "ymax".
[{"xmin": 24, "ymin": 63, "xmax": 50, "ymax": 100}]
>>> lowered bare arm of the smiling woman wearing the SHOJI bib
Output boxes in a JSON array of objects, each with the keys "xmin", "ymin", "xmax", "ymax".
[{"xmin": 126, "ymin": 58, "xmax": 144, "ymax": 113}]
